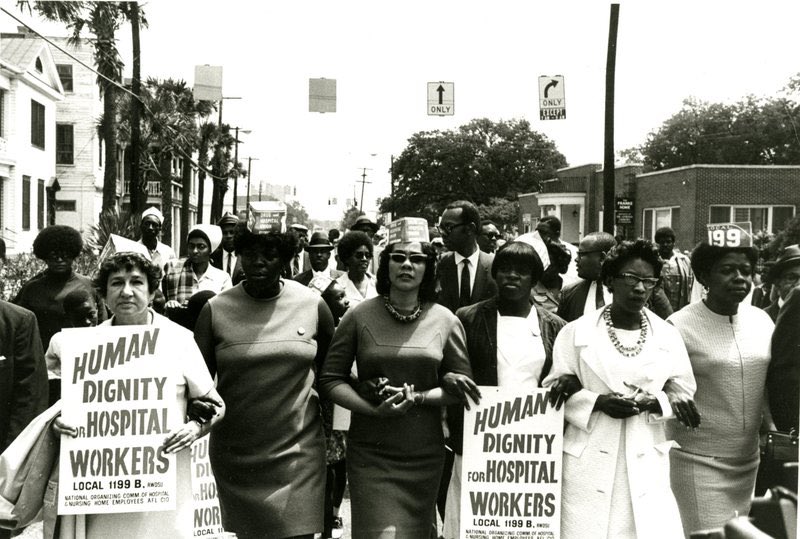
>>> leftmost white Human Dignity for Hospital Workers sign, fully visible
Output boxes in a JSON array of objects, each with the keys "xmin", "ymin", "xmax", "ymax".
[{"xmin": 58, "ymin": 326, "xmax": 182, "ymax": 515}]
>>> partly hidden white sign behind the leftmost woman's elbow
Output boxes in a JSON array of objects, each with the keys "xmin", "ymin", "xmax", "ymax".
[{"xmin": 192, "ymin": 436, "xmax": 228, "ymax": 539}]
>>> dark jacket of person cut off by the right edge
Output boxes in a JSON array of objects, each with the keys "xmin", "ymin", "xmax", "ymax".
[{"xmin": 767, "ymin": 288, "xmax": 800, "ymax": 431}]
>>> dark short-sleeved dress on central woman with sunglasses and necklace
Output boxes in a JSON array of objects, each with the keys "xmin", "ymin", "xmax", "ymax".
[{"xmin": 320, "ymin": 297, "xmax": 472, "ymax": 539}]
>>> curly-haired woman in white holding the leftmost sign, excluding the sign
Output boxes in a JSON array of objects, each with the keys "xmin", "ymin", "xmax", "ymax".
[{"xmin": 55, "ymin": 252, "xmax": 225, "ymax": 539}]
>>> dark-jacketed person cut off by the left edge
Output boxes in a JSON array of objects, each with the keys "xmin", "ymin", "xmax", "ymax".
[{"xmin": 0, "ymin": 301, "xmax": 48, "ymax": 453}]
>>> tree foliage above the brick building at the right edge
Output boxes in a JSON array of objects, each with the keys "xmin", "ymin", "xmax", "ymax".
[{"xmin": 621, "ymin": 83, "xmax": 800, "ymax": 170}]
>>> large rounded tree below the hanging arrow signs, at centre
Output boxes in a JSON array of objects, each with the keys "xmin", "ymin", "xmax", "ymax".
[{"xmin": 381, "ymin": 118, "xmax": 567, "ymax": 227}]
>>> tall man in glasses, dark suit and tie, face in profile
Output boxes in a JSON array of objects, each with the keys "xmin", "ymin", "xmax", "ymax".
[{"xmin": 438, "ymin": 200, "xmax": 497, "ymax": 312}]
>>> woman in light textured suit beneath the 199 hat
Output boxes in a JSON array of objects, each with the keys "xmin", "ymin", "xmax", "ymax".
[{"xmin": 668, "ymin": 243, "xmax": 774, "ymax": 537}]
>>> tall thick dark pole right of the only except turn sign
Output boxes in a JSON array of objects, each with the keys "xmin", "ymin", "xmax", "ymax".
[{"xmin": 603, "ymin": 4, "xmax": 619, "ymax": 234}]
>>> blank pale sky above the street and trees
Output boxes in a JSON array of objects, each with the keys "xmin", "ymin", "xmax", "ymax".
[{"xmin": 0, "ymin": 0, "xmax": 800, "ymax": 219}]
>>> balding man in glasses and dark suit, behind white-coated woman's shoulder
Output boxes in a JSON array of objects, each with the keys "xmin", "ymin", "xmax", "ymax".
[{"xmin": 556, "ymin": 232, "xmax": 617, "ymax": 322}]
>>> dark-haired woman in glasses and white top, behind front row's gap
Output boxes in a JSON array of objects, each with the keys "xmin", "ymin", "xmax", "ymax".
[{"xmin": 336, "ymin": 230, "xmax": 378, "ymax": 308}]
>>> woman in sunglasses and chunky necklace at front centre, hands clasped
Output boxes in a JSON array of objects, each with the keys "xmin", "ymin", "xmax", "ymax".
[{"xmin": 320, "ymin": 231, "xmax": 471, "ymax": 539}]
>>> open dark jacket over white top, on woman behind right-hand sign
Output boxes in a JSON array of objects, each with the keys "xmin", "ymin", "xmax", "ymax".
[{"xmin": 447, "ymin": 298, "xmax": 567, "ymax": 455}]
